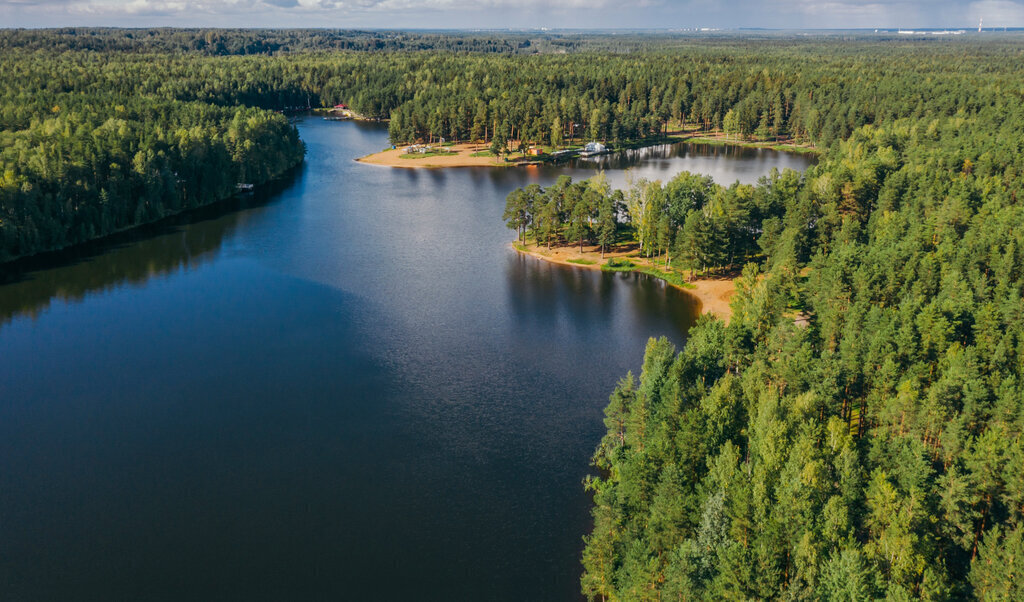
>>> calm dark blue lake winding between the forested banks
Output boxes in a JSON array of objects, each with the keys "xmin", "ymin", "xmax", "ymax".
[{"xmin": 0, "ymin": 119, "xmax": 808, "ymax": 600}]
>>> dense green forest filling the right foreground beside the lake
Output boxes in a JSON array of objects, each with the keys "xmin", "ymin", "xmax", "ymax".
[{"xmin": 565, "ymin": 62, "xmax": 1024, "ymax": 600}]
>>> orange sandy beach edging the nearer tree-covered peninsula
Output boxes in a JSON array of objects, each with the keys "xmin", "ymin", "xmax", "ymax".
[{"xmin": 511, "ymin": 241, "xmax": 736, "ymax": 324}]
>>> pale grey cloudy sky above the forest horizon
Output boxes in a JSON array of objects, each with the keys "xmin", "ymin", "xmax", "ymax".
[{"xmin": 0, "ymin": 0, "xmax": 1024, "ymax": 29}]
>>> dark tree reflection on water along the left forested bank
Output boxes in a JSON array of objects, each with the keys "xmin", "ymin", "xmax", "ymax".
[{"xmin": 0, "ymin": 166, "xmax": 303, "ymax": 327}]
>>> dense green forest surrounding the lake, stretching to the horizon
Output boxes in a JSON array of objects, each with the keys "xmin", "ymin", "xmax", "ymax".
[{"xmin": 0, "ymin": 30, "xmax": 1024, "ymax": 600}]
